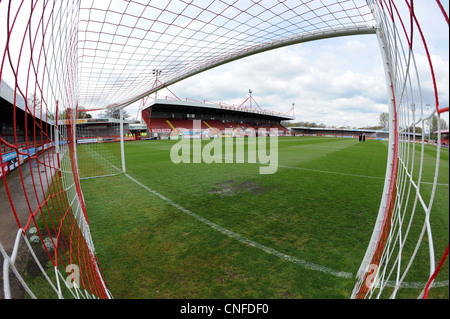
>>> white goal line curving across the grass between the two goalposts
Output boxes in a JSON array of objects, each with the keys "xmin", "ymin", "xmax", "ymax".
[{"xmin": 124, "ymin": 173, "xmax": 353, "ymax": 278}]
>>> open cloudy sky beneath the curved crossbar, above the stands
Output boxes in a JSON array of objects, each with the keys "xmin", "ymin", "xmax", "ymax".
[{"xmin": 121, "ymin": 0, "xmax": 449, "ymax": 127}]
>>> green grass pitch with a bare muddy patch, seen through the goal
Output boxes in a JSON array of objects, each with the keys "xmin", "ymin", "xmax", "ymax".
[{"xmin": 77, "ymin": 137, "xmax": 449, "ymax": 299}]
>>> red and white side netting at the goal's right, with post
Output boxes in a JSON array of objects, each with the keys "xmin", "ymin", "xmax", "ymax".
[{"xmin": 352, "ymin": 1, "xmax": 448, "ymax": 298}]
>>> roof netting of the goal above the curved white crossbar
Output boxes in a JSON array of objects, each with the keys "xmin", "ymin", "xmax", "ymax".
[{"xmin": 78, "ymin": 0, "xmax": 375, "ymax": 109}]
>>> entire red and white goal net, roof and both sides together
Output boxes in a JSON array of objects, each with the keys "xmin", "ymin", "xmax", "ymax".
[{"xmin": 0, "ymin": 0, "xmax": 448, "ymax": 298}]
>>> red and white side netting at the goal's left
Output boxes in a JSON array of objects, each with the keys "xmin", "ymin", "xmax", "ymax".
[{"xmin": 0, "ymin": 1, "xmax": 108, "ymax": 298}]
